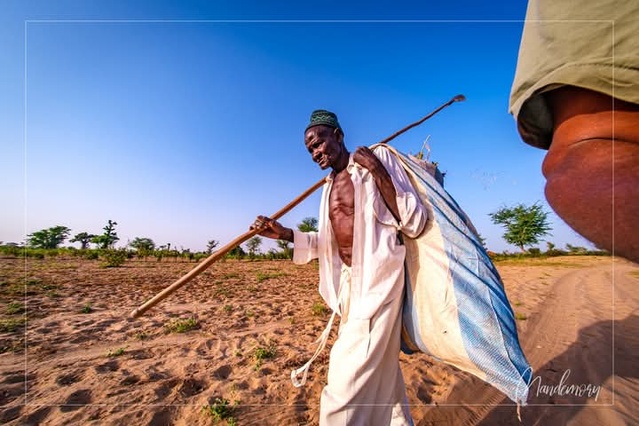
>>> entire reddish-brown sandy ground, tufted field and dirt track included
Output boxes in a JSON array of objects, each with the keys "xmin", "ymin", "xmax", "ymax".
[{"xmin": 0, "ymin": 256, "xmax": 639, "ymax": 426}]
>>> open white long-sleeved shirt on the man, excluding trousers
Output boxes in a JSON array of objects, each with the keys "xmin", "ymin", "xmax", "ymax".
[{"xmin": 293, "ymin": 146, "xmax": 427, "ymax": 319}]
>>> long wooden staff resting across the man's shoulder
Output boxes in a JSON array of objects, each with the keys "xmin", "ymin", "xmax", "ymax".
[{"xmin": 129, "ymin": 95, "xmax": 466, "ymax": 318}]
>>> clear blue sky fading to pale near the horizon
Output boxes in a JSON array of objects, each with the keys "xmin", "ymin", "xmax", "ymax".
[{"xmin": 0, "ymin": 0, "xmax": 591, "ymax": 251}]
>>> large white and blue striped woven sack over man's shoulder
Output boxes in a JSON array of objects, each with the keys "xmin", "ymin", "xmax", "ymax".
[{"xmin": 376, "ymin": 145, "xmax": 532, "ymax": 404}]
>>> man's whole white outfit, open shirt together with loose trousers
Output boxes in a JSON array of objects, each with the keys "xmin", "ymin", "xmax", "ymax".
[{"xmin": 293, "ymin": 146, "xmax": 427, "ymax": 426}]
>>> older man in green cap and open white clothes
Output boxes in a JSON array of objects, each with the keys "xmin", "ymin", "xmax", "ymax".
[{"xmin": 253, "ymin": 110, "xmax": 427, "ymax": 426}]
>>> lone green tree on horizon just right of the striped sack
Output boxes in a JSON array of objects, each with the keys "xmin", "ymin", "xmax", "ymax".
[{"xmin": 489, "ymin": 203, "xmax": 552, "ymax": 252}]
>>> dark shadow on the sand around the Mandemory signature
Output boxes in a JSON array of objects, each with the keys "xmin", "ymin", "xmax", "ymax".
[{"xmin": 478, "ymin": 315, "xmax": 639, "ymax": 426}]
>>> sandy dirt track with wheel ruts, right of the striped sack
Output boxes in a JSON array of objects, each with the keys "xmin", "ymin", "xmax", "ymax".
[{"xmin": 419, "ymin": 259, "xmax": 639, "ymax": 426}]
